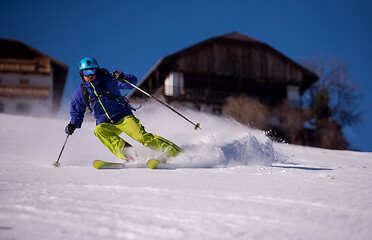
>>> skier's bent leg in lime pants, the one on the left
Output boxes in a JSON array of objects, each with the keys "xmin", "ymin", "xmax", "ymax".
[{"xmin": 94, "ymin": 123, "xmax": 130, "ymax": 160}]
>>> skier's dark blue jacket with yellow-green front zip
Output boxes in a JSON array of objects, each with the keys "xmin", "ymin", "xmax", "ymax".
[{"xmin": 70, "ymin": 69, "xmax": 137, "ymax": 128}]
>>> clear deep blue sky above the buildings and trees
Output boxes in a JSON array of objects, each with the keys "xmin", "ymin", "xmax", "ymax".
[{"xmin": 0, "ymin": 0, "xmax": 372, "ymax": 151}]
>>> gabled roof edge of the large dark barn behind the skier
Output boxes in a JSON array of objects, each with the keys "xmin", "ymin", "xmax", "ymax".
[{"xmin": 138, "ymin": 32, "xmax": 318, "ymax": 89}]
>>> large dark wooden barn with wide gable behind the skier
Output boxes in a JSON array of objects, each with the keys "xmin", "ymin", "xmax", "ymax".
[{"xmin": 130, "ymin": 32, "xmax": 318, "ymax": 113}]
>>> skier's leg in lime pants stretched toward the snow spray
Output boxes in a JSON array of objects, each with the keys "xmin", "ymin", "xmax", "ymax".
[{"xmin": 117, "ymin": 115, "xmax": 182, "ymax": 157}]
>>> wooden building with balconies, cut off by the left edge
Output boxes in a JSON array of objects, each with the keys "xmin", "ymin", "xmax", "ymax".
[{"xmin": 0, "ymin": 38, "xmax": 68, "ymax": 115}]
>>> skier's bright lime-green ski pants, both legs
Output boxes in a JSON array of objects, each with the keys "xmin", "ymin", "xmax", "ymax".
[{"xmin": 94, "ymin": 115, "xmax": 182, "ymax": 160}]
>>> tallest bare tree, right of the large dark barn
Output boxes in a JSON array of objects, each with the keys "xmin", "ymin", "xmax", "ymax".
[{"xmin": 302, "ymin": 55, "xmax": 362, "ymax": 149}]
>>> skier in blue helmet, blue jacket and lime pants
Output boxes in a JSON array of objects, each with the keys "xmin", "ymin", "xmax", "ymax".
[{"xmin": 65, "ymin": 57, "xmax": 182, "ymax": 161}]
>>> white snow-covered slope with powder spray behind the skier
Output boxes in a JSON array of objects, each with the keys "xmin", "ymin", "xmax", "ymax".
[{"xmin": 0, "ymin": 104, "xmax": 372, "ymax": 240}]
